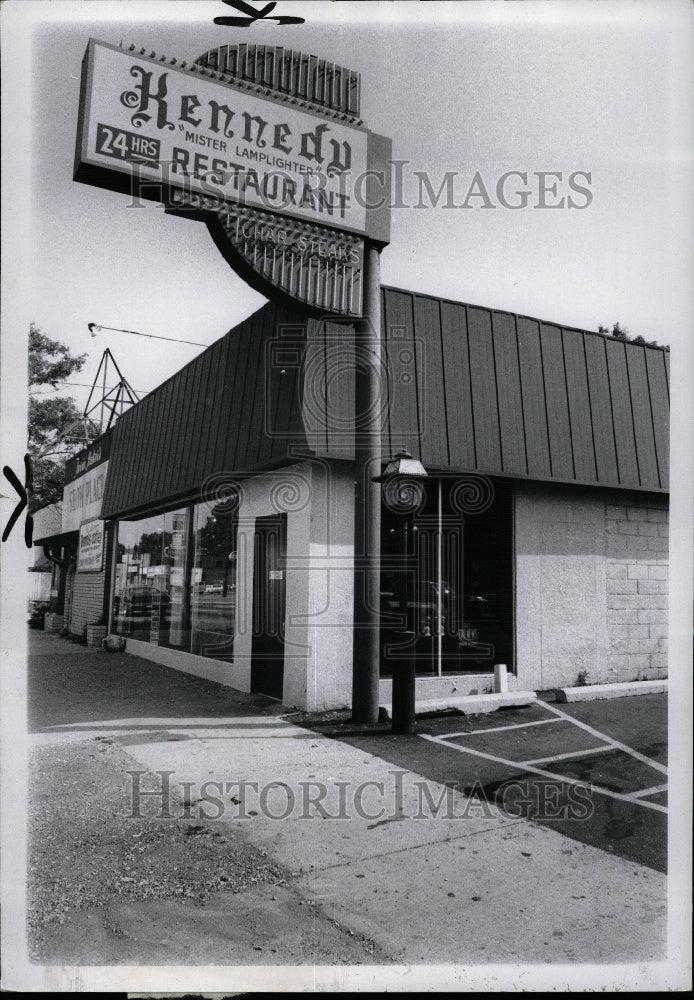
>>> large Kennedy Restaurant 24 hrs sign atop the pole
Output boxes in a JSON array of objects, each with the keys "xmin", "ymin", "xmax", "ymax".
[{"xmin": 74, "ymin": 39, "xmax": 390, "ymax": 315}]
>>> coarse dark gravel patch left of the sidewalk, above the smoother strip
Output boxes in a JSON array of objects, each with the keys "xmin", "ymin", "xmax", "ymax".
[{"xmin": 28, "ymin": 737, "xmax": 284, "ymax": 957}]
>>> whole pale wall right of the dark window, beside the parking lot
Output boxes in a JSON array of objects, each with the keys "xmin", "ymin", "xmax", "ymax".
[{"xmin": 514, "ymin": 483, "xmax": 668, "ymax": 690}]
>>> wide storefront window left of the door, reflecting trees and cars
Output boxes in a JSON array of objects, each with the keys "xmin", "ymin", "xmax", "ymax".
[{"xmin": 111, "ymin": 503, "xmax": 237, "ymax": 659}]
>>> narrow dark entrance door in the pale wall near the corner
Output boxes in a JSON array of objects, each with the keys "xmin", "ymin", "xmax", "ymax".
[{"xmin": 251, "ymin": 514, "xmax": 287, "ymax": 701}]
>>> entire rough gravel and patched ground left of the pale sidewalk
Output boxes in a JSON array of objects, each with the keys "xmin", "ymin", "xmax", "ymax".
[{"xmin": 27, "ymin": 734, "xmax": 392, "ymax": 965}]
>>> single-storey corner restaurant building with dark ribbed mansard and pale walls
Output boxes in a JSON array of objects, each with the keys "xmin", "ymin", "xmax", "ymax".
[{"xmin": 95, "ymin": 288, "xmax": 669, "ymax": 710}]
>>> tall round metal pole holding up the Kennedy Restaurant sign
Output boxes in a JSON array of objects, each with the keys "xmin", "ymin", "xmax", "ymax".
[{"xmin": 352, "ymin": 241, "xmax": 383, "ymax": 724}]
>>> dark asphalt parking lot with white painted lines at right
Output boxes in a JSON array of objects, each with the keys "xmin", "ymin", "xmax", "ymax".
[{"xmin": 315, "ymin": 694, "xmax": 668, "ymax": 872}]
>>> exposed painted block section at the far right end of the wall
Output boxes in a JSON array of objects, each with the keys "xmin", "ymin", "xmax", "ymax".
[{"xmin": 605, "ymin": 501, "xmax": 668, "ymax": 679}]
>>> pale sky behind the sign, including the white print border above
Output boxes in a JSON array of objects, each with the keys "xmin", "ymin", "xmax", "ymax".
[{"xmin": 3, "ymin": 0, "xmax": 694, "ymax": 414}]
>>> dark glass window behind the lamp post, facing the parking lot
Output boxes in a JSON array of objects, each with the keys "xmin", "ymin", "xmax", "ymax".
[{"xmin": 381, "ymin": 476, "xmax": 513, "ymax": 675}]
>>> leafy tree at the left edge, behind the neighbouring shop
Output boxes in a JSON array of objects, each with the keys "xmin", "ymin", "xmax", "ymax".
[{"xmin": 28, "ymin": 323, "xmax": 98, "ymax": 511}]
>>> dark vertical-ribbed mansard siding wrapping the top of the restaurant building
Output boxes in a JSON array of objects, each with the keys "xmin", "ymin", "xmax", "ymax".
[{"xmin": 103, "ymin": 288, "xmax": 669, "ymax": 516}]
